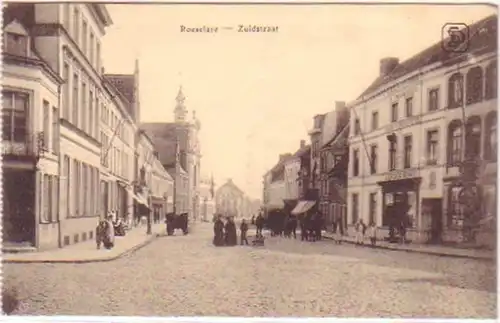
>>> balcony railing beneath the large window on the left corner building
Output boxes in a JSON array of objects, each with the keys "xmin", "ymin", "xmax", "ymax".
[{"xmin": 0, "ymin": 132, "xmax": 46, "ymax": 161}]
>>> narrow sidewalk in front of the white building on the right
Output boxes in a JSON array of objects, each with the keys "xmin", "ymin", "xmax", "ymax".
[{"xmin": 323, "ymin": 232, "xmax": 496, "ymax": 260}]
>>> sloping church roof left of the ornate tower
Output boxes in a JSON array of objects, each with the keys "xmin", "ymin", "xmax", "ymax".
[{"xmin": 139, "ymin": 122, "xmax": 176, "ymax": 165}]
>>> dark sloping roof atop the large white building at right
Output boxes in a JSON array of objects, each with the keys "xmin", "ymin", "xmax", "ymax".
[{"xmin": 358, "ymin": 15, "xmax": 497, "ymax": 99}]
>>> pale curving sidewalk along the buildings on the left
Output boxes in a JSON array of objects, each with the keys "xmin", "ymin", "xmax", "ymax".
[{"xmin": 2, "ymin": 223, "xmax": 165, "ymax": 263}]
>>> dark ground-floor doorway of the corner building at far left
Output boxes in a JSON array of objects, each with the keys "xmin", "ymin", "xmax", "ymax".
[{"xmin": 2, "ymin": 169, "xmax": 35, "ymax": 245}]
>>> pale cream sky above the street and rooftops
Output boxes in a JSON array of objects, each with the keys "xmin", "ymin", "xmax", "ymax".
[{"xmin": 99, "ymin": 4, "xmax": 496, "ymax": 198}]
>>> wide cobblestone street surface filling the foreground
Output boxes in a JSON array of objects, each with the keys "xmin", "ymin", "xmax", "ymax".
[{"xmin": 3, "ymin": 224, "xmax": 496, "ymax": 318}]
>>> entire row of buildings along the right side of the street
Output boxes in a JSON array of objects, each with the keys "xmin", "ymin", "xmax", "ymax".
[{"xmin": 264, "ymin": 16, "xmax": 498, "ymax": 245}]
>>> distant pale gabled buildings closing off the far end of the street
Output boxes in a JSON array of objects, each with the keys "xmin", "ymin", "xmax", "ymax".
[{"xmin": 215, "ymin": 179, "xmax": 261, "ymax": 219}]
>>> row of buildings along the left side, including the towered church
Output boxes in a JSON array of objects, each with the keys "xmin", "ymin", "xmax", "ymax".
[{"xmin": 2, "ymin": 3, "xmax": 214, "ymax": 250}]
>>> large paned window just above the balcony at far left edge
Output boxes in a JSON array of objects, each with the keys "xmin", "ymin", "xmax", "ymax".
[{"xmin": 2, "ymin": 91, "xmax": 29, "ymax": 142}]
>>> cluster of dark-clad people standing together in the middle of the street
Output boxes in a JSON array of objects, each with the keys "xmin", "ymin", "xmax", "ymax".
[{"xmin": 213, "ymin": 215, "xmax": 248, "ymax": 247}]
